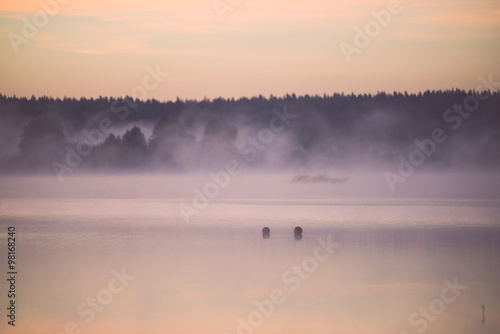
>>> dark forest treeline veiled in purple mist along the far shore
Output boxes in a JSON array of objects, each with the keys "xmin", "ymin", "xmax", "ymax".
[{"xmin": 0, "ymin": 90, "xmax": 500, "ymax": 173}]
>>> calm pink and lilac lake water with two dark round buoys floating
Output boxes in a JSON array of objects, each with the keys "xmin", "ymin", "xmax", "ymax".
[{"xmin": 0, "ymin": 198, "xmax": 500, "ymax": 334}]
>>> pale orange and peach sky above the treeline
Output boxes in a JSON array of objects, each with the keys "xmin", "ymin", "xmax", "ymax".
[{"xmin": 0, "ymin": 0, "xmax": 500, "ymax": 101}]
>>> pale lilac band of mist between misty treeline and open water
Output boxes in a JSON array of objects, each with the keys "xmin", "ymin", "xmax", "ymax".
[{"xmin": 0, "ymin": 171, "xmax": 500, "ymax": 201}]
